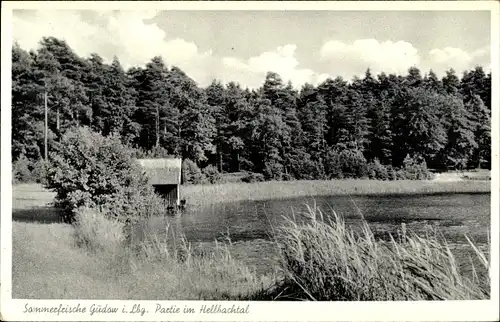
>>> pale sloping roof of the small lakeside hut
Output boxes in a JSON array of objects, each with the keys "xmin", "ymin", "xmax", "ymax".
[{"xmin": 137, "ymin": 158, "xmax": 182, "ymax": 185}]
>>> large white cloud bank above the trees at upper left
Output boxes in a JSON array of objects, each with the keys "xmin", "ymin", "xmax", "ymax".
[{"xmin": 13, "ymin": 10, "xmax": 212, "ymax": 82}]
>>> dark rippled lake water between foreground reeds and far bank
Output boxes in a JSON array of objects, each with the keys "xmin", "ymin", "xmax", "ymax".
[{"xmin": 136, "ymin": 193, "xmax": 490, "ymax": 274}]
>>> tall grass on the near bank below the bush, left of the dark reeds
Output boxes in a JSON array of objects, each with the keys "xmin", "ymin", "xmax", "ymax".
[{"xmin": 66, "ymin": 209, "xmax": 273, "ymax": 300}]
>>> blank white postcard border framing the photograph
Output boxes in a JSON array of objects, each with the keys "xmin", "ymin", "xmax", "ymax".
[{"xmin": 0, "ymin": 1, "xmax": 500, "ymax": 321}]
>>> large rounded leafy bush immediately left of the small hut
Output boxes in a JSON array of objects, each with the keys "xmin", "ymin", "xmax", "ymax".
[{"xmin": 46, "ymin": 127, "xmax": 153, "ymax": 221}]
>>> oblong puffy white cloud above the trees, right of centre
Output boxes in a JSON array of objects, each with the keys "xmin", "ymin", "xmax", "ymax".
[{"xmin": 320, "ymin": 39, "xmax": 420, "ymax": 78}]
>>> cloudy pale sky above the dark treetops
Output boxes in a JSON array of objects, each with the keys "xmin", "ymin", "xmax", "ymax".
[{"xmin": 13, "ymin": 10, "xmax": 491, "ymax": 88}]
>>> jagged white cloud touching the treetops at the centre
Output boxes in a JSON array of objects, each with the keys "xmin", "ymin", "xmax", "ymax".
[{"xmin": 222, "ymin": 44, "xmax": 329, "ymax": 88}]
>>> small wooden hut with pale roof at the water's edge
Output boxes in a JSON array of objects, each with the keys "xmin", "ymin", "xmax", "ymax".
[{"xmin": 137, "ymin": 158, "xmax": 182, "ymax": 208}]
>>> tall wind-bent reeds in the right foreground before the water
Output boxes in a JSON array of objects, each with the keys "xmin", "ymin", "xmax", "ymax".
[{"xmin": 274, "ymin": 207, "xmax": 490, "ymax": 301}]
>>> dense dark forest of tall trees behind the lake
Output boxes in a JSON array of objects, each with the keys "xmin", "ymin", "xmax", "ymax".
[{"xmin": 12, "ymin": 37, "xmax": 491, "ymax": 180}]
